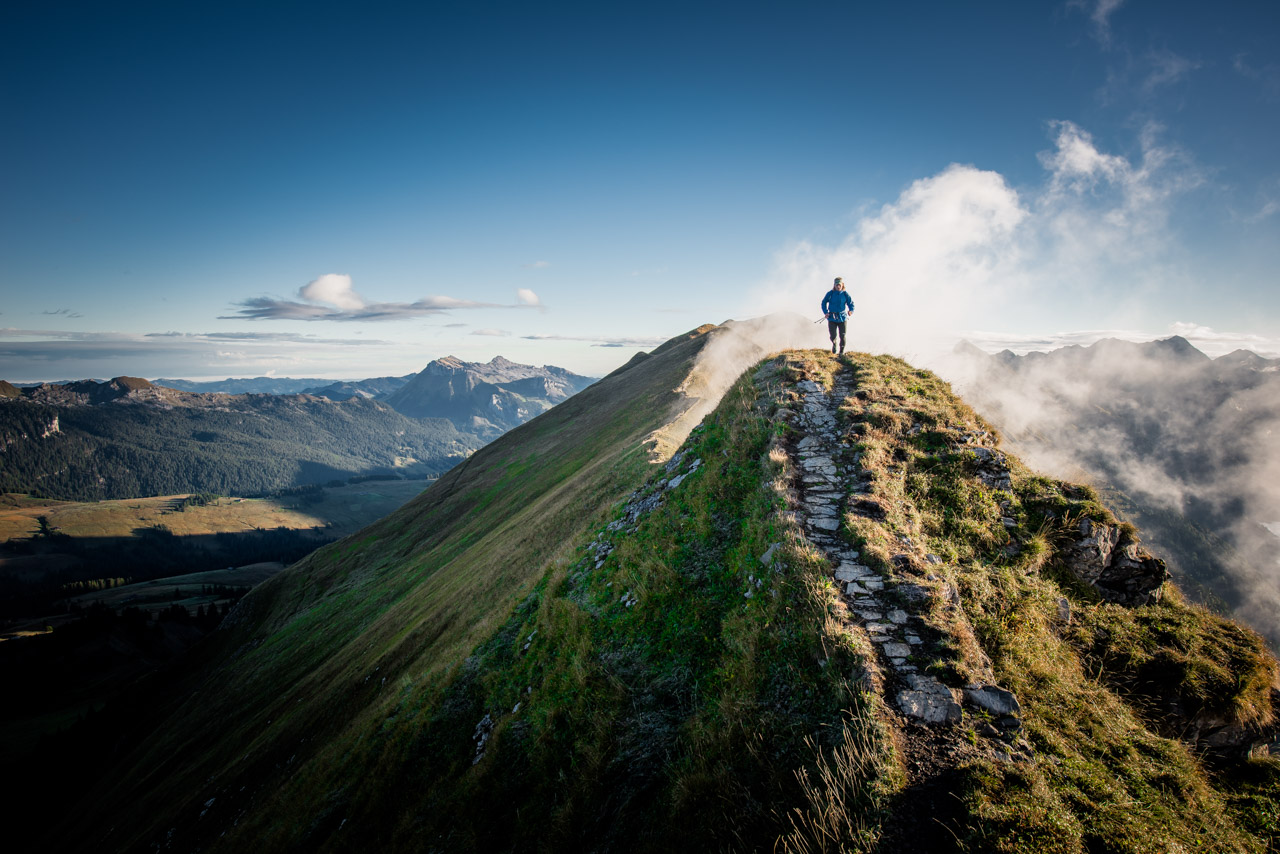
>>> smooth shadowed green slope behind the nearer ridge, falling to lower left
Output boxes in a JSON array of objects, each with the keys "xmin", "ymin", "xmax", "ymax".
[{"xmin": 64, "ymin": 326, "xmax": 723, "ymax": 849}]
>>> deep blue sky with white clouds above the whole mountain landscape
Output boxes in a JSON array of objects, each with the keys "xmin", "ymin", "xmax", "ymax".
[{"xmin": 0, "ymin": 0, "xmax": 1280, "ymax": 382}]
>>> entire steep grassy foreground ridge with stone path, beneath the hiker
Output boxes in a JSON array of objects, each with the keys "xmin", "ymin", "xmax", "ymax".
[{"xmin": 54, "ymin": 338, "xmax": 1280, "ymax": 854}]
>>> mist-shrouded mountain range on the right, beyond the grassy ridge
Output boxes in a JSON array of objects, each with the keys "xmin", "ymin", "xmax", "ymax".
[{"xmin": 954, "ymin": 337, "xmax": 1280, "ymax": 644}]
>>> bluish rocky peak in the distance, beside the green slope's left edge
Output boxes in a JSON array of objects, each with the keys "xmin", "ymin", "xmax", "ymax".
[{"xmin": 385, "ymin": 356, "xmax": 595, "ymax": 439}]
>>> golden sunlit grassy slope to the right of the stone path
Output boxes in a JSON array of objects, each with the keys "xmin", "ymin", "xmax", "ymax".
[{"xmin": 850, "ymin": 357, "xmax": 1280, "ymax": 854}]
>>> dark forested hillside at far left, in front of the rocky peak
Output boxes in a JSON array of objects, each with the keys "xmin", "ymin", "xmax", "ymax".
[{"xmin": 0, "ymin": 378, "xmax": 481, "ymax": 501}]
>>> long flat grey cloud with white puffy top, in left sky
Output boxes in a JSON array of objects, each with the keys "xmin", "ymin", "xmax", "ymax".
[{"xmin": 219, "ymin": 273, "xmax": 541, "ymax": 321}]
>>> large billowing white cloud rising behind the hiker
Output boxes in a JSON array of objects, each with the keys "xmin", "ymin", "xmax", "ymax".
[{"xmin": 749, "ymin": 122, "xmax": 1202, "ymax": 361}]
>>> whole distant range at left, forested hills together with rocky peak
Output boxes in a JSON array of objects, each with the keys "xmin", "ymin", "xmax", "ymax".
[{"xmin": 0, "ymin": 356, "xmax": 594, "ymax": 501}]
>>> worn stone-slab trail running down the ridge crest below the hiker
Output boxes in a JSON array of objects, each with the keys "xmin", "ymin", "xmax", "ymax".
[{"xmin": 785, "ymin": 367, "xmax": 1033, "ymax": 844}]
